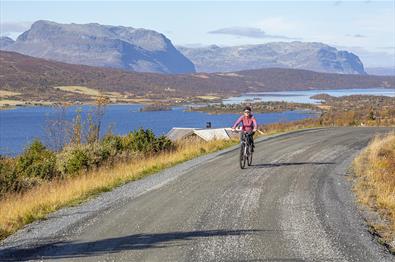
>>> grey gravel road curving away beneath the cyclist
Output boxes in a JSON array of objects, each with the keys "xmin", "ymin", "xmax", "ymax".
[{"xmin": 0, "ymin": 128, "xmax": 394, "ymax": 261}]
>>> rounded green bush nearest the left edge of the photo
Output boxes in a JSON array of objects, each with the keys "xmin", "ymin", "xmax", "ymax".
[{"xmin": 16, "ymin": 140, "xmax": 58, "ymax": 179}]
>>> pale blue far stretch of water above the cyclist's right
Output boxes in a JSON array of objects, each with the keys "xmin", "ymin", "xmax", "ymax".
[{"xmin": 224, "ymin": 88, "xmax": 395, "ymax": 104}]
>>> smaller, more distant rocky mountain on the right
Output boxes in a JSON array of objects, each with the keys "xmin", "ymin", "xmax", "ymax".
[{"xmin": 177, "ymin": 41, "xmax": 366, "ymax": 75}]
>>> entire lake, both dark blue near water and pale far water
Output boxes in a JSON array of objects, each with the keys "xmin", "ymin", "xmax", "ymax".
[{"xmin": 0, "ymin": 88, "xmax": 395, "ymax": 155}]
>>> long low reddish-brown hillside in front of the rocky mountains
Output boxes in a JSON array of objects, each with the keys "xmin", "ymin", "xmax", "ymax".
[{"xmin": 0, "ymin": 51, "xmax": 395, "ymax": 101}]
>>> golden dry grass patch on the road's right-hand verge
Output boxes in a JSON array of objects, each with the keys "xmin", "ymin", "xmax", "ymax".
[{"xmin": 353, "ymin": 132, "xmax": 395, "ymax": 251}]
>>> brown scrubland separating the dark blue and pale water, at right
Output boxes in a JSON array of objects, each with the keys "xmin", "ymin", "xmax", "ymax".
[{"xmin": 198, "ymin": 94, "xmax": 395, "ymax": 128}]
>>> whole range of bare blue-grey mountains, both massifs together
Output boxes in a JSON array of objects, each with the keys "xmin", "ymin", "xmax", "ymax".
[{"xmin": 0, "ymin": 20, "xmax": 372, "ymax": 74}]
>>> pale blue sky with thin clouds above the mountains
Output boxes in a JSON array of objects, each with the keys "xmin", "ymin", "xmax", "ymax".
[{"xmin": 0, "ymin": 0, "xmax": 395, "ymax": 67}]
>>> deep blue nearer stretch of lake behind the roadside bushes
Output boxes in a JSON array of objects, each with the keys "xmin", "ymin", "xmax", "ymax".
[{"xmin": 0, "ymin": 105, "xmax": 318, "ymax": 155}]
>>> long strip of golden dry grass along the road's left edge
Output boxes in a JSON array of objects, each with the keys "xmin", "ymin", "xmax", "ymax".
[{"xmin": 0, "ymin": 140, "xmax": 235, "ymax": 239}]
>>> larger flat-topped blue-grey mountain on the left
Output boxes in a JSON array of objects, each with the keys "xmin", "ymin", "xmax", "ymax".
[{"xmin": 0, "ymin": 21, "xmax": 195, "ymax": 74}]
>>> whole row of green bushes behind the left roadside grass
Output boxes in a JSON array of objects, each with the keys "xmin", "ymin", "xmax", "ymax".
[{"xmin": 0, "ymin": 129, "xmax": 174, "ymax": 196}]
